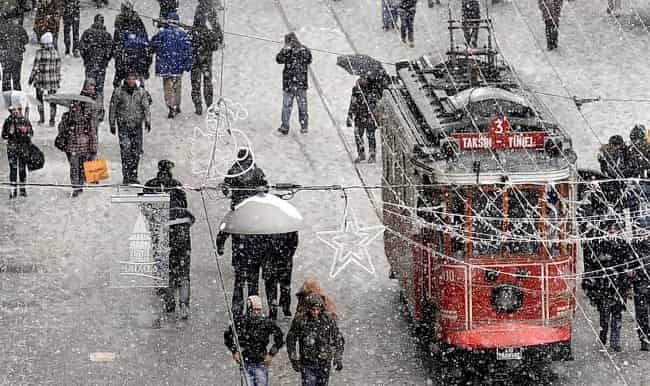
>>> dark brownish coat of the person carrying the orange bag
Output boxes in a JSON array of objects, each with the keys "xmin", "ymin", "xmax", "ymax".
[{"xmin": 59, "ymin": 108, "xmax": 97, "ymax": 154}]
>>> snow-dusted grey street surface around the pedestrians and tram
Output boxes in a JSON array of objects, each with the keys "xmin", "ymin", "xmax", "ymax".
[{"xmin": 0, "ymin": 0, "xmax": 650, "ymax": 385}]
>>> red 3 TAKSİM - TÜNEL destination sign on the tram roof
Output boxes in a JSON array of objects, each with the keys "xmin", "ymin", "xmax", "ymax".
[{"xmin": 451, "ymin": 117, "xmax": 546, "ymax": 150}]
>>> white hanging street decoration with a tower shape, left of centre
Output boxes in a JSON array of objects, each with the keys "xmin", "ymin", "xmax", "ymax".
[{"xmin": 110, "ymin": 194, "xmax": 169, "ymax": 288}]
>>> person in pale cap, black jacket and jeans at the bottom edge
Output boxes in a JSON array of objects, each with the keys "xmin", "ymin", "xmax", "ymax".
[{"xmin": 223, "ymin": 295, "xmax": 284, "ymax": 386}]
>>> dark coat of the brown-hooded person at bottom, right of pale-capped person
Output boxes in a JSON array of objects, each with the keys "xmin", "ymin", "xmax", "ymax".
[{"xmin": 287, "ymin": 306, "xmax": 345, "ymax": 368}]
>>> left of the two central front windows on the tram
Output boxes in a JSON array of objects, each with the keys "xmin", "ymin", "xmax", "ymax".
[{"xmin": 472, "ymin": 190, "xmax": 503, "ymax": 256}]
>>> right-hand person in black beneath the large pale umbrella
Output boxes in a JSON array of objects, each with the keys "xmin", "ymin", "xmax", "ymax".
[{"xmin": 262, "ymin": 232, "xmax": 298, "ymax": 320}]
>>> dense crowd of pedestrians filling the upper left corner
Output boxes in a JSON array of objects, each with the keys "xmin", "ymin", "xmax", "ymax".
[{"xmin": 0, "ymin": 0, "xmax": 223, "ymax": 199}]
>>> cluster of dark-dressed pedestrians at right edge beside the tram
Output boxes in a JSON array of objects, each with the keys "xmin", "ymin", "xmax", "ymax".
[{"xmin": 579, "ymin": 124, "xmax": 650, "ymax": 351}]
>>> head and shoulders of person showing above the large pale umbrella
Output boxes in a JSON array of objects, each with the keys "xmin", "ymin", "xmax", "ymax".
[{"xmin": 222, "ymin": 147, "xmax": 268, "ymax": 210}]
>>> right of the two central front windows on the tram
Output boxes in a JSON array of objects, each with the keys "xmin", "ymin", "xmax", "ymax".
[{"xmin": 506, "ymin": 189, "xmax": 539, "ymax": 255}]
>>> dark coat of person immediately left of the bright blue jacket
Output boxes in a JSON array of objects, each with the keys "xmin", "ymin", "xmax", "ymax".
[{"xmin": 113, "ymin": 13, "xmax": 152, "ymax": 79}]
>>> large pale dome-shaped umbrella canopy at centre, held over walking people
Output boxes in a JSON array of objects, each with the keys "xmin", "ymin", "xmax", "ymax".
[{"xmin": 220, "ymin": 193, "xmax": 302, "ymax": 235}]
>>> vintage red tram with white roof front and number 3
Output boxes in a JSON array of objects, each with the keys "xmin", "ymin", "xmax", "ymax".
[{"xmin": 377, "ymin": 20, "xmax": 576, "ymax": 380}]
